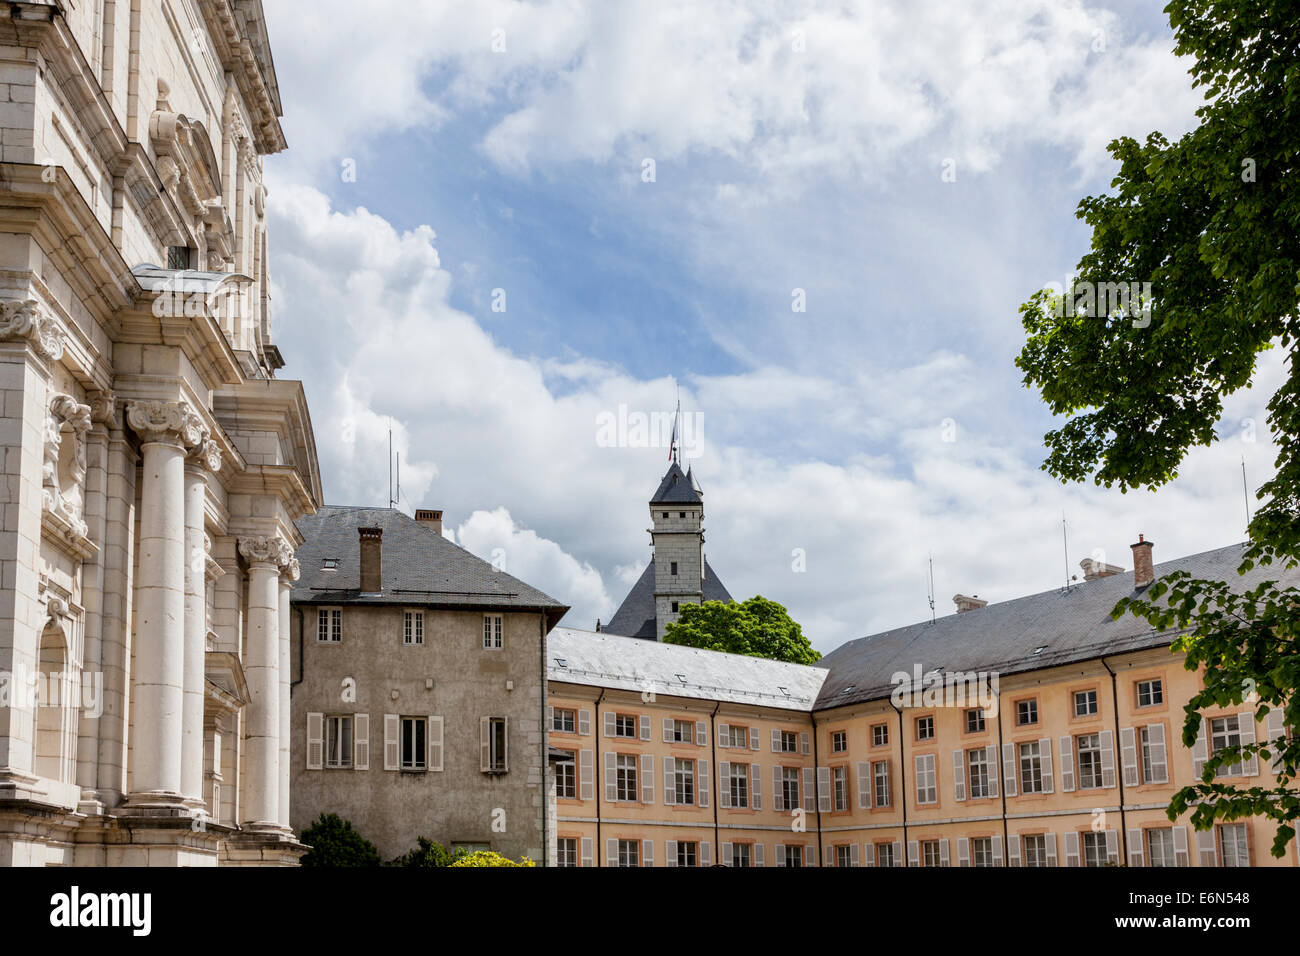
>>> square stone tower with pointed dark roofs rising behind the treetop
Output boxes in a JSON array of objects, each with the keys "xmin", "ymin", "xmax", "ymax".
[{"xmin": 603, "ymin": 460, "xmax": 732, "ymax": 641}]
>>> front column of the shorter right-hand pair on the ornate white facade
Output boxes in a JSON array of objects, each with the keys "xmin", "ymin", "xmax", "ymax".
[{"xmin": 239, "ymin": 535, "xmax": 293, "ymax": 830}]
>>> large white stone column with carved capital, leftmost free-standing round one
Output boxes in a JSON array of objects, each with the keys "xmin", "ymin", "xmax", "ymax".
[{"xmin": 126, "ymin": 402, "xmax": 204, "ymax": 805}]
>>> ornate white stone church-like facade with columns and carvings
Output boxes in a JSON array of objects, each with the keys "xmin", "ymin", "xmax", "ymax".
[{"xmin": 0, "ymin": 0, "xmax": 321, "ymax": 865}]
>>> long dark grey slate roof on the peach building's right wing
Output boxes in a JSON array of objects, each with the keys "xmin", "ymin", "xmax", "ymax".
[{"xmin": 814, "ymin": 545, "xmax": 1300, "ymax": 710}]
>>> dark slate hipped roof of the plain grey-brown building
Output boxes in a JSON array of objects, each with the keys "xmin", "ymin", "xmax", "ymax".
[{"xmin": 291, "ymin": 506, "xmax": 568, "ymax": 627}]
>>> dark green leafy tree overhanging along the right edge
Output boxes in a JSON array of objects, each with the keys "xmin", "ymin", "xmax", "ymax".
[{"xmin": 1017, "ymin": 0, "xmax": 1300, "ymax": 856}]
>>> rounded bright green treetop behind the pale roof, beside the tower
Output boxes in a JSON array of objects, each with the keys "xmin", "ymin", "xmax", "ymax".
[{"xmin": 663, "ymin": 594, "xmax": 822, "ymax": 663}]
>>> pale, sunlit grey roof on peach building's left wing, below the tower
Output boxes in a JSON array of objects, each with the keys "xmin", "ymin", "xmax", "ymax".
[{"xmin": 546, "ymin": 627, "xmax": 826, "ymax": 711}]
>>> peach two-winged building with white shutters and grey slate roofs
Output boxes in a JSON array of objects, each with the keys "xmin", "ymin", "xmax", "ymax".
[{"xmin": 547, "ymin": 542, "xmax": 1297, "ymax": 866}]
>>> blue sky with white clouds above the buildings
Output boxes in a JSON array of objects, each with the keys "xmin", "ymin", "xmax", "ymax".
[{"xmin": 258, "ymin": 0, "xmax": 1277, "ymax": 652}]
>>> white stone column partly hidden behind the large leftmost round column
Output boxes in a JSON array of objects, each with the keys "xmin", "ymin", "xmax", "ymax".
[{"xmin": 181, "ymin": 440, "xmax": 221, "ymax": 804}]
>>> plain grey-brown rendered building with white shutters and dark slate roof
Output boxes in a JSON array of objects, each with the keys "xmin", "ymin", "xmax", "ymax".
[{"xmin": 290, "ymin": 507, "xmax": 568, "ymax": 864}]
